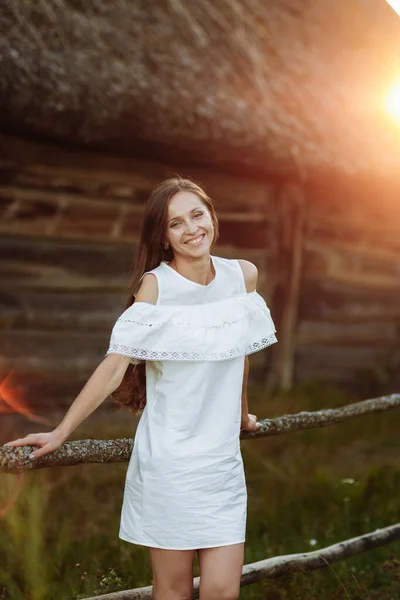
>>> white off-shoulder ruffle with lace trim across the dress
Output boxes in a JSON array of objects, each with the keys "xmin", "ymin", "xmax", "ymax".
[{"xmin": 106, "ymin": 292, "xmax": 278, "ymax": 362}]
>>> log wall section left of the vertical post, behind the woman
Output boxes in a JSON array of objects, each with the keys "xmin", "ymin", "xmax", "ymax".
[{"xmin": 0, "ymin": 138, "xmax": 275, "ymax": 409}]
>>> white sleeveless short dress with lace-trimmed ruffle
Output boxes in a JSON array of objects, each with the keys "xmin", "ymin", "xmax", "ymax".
[{"xmin": 107, "ymin": 256, "xmax": 277, "ymax": 550}]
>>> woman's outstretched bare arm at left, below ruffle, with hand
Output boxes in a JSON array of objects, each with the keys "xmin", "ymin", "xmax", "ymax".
[{"xmin": 6, "ymin": 354, "xmax": 130, "ymax": 460}]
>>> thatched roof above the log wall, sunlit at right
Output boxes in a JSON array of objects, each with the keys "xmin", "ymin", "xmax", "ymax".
[{"xmin": 0, "ymin": 0, "xmax": 400, "ymax": 177}]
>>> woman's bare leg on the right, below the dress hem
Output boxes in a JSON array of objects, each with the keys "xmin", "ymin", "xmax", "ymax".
[{"xmin": 198, "ymin": 542, "xmax": 244, "ymax": 600}]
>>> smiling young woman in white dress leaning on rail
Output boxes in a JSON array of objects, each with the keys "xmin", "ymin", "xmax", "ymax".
[{"xmin": 3, "ymin": 177, "xmax": 277, "ymax": 600}]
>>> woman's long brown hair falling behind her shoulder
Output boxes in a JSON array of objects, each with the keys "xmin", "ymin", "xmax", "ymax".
[{"xmin": 111, "ymin": 176, "xmax": 218, "ymax": 414}]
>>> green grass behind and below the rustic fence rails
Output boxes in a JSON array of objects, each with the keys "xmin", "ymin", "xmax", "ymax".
[{"xmin": 0, "ymin": 382, "xmax": 400, "ymax": 600}]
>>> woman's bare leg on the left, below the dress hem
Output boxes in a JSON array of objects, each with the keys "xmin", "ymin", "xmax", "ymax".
[{"xmin": 150, "ymin": 548, "xmax": 196, "ymax": 600}]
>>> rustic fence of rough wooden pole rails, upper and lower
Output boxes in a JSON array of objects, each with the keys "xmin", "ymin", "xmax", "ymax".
[{"xmin": 0, "ymin": 394, "xmax": 400, "ymax": 600}]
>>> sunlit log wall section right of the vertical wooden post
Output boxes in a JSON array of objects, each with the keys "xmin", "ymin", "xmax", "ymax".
[{"xmin": 294, "ymin": 181, "xmax": 400, "ymax": 394}]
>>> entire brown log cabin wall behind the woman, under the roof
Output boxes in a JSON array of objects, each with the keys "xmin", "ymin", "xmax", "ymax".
[{"xmin": 0, "ymin": 137, "xmax": 400, "ymax": 410}]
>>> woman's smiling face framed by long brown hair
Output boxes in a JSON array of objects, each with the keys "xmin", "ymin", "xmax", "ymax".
[{"xmin": 165, "ymin": 190, "xmax": 214, "ymax": 257}]
